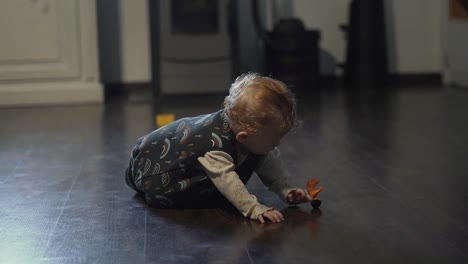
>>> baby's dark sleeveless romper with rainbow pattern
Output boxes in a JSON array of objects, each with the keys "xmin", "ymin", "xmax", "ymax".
[{"xmin": 125, "ymin": 110, "xmax": 261, "ymax": 208}]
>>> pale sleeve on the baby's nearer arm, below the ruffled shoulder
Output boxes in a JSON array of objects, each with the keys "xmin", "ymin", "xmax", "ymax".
[{"xmin": 198, "ymin": 151, "xmax": 272, "ymax": 219}]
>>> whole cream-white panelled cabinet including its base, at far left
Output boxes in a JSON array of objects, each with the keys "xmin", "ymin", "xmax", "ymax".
[{"xmin": 0, "ymin": 0, "xmax": 103, "ymax": 106}]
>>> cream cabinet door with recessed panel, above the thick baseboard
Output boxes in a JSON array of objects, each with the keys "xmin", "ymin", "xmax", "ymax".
[{"xmin": 0, "ymin": 0, "xmax": 80, "ymax": 82}]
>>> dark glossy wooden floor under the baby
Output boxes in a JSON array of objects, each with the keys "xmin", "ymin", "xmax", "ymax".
[{"xmin": 0, "ymin": 87, "xmax": 468, "ymax": 264}]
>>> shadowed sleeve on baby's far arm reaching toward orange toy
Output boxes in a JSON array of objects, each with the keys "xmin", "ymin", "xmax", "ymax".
[{"xmin": 255, "ymin": 148, "xmax": 297, "ymax": 201}]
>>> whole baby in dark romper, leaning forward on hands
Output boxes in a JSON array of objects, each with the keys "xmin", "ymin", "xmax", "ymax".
[{"xmin": 126, "ymin": 73, "xmax": 312, "ymax": 222}]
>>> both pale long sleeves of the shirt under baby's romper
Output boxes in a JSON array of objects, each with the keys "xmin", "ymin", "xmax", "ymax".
[{"xmin": 198, "ymin": 148, "xmax": 295, "ymax": 219}]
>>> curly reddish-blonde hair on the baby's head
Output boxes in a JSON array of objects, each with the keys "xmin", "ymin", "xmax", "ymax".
[{"xmin": 223, "ymin": 73, "xmax": 302, "ymax": 134}]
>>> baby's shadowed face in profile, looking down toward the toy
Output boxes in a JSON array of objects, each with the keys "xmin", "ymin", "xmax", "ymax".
[{"xmin": 242, "ymin": 116, "xmax": 286, "ymax": 155}]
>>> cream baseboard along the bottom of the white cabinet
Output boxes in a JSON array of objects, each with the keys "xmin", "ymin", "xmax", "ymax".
[{"xmin": 0, "ymin": 82, "xmax": 104, "ymax": 107}]
